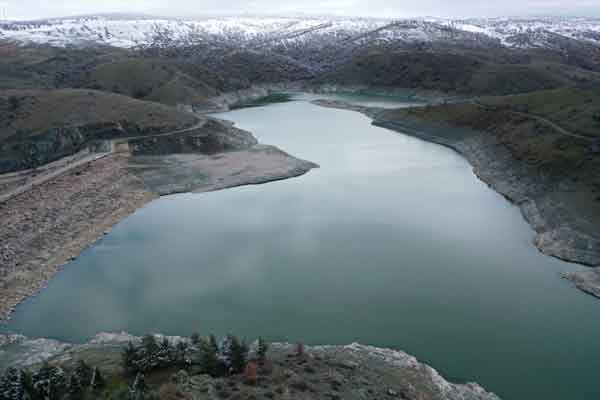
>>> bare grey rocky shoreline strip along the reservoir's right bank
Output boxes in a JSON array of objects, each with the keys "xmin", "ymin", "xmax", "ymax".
[{"xmin": 313, "ymin": 100, "xmax": 600, "ymax": 298}]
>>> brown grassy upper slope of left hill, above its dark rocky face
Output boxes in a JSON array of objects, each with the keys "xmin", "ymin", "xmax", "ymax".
[{"xmin": 0, "ymin": 89, "xmax": 195, "ymax": 143}]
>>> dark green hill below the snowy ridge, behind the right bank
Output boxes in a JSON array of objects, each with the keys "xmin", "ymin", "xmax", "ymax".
[{"xmin": 319, "ymin": 51, "xmax": 600, "ymax": 95}]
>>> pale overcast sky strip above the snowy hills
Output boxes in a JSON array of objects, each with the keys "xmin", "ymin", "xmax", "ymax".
[{"xmin": 0, "ymin": 0, "xmax": 600, "ymax": 19}]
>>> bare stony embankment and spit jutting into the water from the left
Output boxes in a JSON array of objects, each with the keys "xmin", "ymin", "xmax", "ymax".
[{"xmin": 0, "ymin": 117, "xmax": 318, "ymax": 321}]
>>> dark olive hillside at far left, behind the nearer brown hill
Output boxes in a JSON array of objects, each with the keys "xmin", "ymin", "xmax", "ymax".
[{"xmin": 0, "ymin": 41, "xmax": 224, "ymax": 105}]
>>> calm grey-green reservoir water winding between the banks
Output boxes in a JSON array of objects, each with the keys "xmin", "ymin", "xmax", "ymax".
[{"xmin": 2, "ymin": 95, "xmax": 600, "ymax": 400}]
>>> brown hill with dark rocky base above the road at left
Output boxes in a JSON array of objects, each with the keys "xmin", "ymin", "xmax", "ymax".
[{"xmin": 0, "ymin": 89, "xmax": 200, "ymax": 173}]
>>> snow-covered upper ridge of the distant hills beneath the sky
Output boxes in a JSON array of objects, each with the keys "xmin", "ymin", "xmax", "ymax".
[{"xmin": 0, "ymin": 15, "xmax": 600, "ymax": 48}]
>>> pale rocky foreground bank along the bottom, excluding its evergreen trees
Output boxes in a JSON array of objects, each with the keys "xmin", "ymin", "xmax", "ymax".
[{"xmin": 0, "ymin": 333, "xmax": 499, "ymax": 400}]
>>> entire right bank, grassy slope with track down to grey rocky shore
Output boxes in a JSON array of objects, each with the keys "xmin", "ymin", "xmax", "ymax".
[{"xmin": 319, "ymin": 88, "xmax": 600, "ymax": 297}]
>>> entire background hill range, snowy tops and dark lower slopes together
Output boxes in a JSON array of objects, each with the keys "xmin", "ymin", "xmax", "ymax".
[{"xmin": 0, "ymin": 16, "xmax": 600, "ymax": 105}]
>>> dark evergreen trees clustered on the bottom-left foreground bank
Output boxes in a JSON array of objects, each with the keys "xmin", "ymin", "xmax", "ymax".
[{"xmin": 0, "ymin": 334, "xmax": 267, "ymax": 400}]
